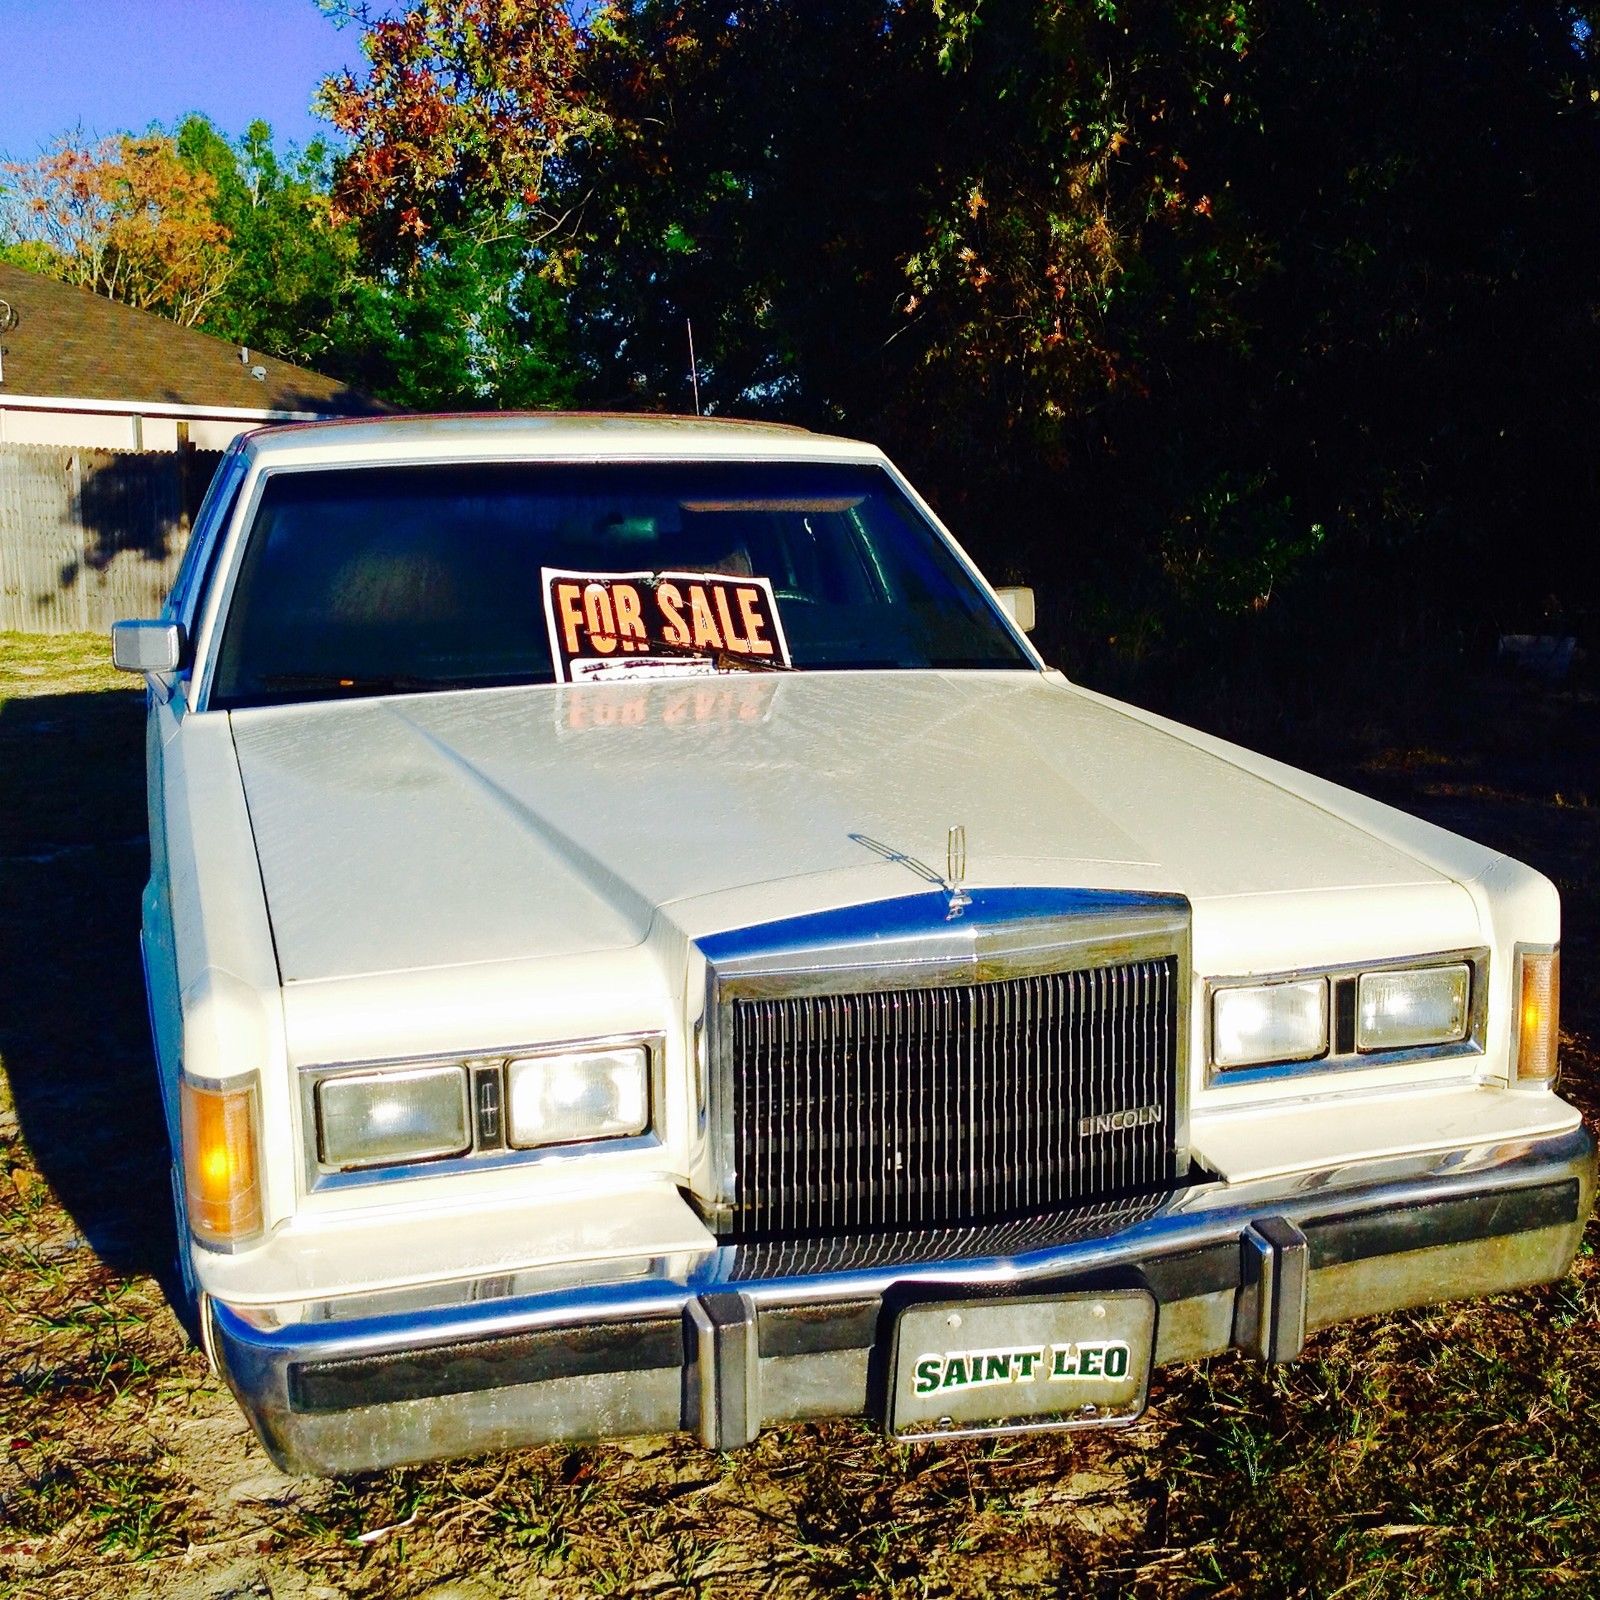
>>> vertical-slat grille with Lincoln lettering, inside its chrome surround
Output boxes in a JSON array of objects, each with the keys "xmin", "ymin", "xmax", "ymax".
[{"xmin": 728, "ymin": 955, "xmax": 1179, "ymax": 1237}]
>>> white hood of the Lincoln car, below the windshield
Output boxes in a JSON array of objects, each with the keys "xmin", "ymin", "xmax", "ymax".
[{"xmin": 230, "ymin": 672, "xmax": 1448, "ymax": 982}]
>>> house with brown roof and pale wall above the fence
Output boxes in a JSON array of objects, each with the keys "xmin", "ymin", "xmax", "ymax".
[{"xmin": 0, "ymin": 262, "xmax": 381, "ymax": 451}]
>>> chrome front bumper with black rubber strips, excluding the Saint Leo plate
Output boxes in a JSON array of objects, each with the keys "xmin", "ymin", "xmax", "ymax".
[{"xmin": 208, "ymin": 1130, "xmax": 1595, "ymax": 1474}]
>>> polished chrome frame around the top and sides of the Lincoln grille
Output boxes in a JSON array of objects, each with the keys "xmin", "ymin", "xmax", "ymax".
[{"xmin": 694, "ymin": 890, "xmax": 1192, "ymax": 1230}]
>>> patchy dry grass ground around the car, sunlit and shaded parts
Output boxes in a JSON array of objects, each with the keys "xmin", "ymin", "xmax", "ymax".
[{"xmin": 0, "ymin": 635, "xmax": 1600, "ymax": 1600}]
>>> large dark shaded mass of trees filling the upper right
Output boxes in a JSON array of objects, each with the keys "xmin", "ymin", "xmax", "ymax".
[{"xmin": 562, "ymin": 0, "xmax": 1600, "ymax": 667}]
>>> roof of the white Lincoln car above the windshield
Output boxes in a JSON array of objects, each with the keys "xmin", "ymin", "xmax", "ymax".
[{"xmin": 243, "ymin": 411, "xmax": 883, "ymax": 467}]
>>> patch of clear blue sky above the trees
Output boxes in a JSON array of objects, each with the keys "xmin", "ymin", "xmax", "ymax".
[{"xmin": 0, "ymin": 0, "xmax": 362, "ymax": 160}]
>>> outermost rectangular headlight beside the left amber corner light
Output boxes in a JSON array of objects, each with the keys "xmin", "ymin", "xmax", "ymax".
[{"xmin": 317, "ymin": 1066, "xmax": 472, "ymax": 1168}]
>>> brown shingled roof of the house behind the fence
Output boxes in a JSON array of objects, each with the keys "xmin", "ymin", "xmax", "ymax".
[{"xmin": 0, "ymin": 262, "xmax": 374, "ymax": 416}]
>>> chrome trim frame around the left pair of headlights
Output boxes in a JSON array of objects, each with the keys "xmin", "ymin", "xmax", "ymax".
[{"xmin": 296, "ymin": 1032, "xmax": 667, "ymax": 1194}]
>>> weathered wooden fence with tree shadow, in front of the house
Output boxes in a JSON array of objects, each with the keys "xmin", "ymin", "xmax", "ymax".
[{"xmin": 0, "ymin": 445, "xmax": 221, "ymax": 634}]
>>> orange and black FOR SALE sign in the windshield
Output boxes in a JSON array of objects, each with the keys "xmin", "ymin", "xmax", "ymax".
[{"xmin": 541, "ymin": 566, "xmax": 789, "ymax": 683}]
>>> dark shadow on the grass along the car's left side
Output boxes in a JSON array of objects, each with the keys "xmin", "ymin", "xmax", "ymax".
[{"xmin": 0, "ymin": 693, "xmax": 173, "ymax": 1288}]
